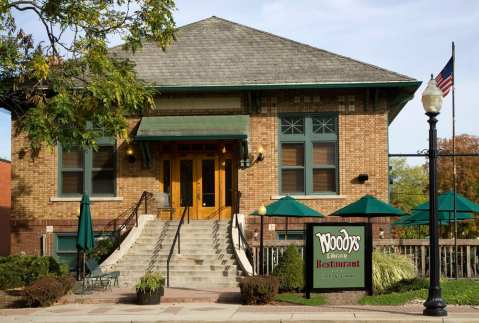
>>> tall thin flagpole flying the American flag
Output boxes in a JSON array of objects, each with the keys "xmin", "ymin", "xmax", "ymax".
[{"xmin": 452, "ymin": 42, "xmax": 459, "ymax": 279}]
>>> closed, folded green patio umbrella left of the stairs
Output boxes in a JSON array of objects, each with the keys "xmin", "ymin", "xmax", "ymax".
[{"xmin": 76, "ymin": 193, "xmax": 95, "ymax": 281}]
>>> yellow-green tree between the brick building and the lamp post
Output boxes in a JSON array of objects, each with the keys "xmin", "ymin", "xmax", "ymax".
[{"xmin": 390, "ymin": 158, "xmax": 428, "ymax": 212}]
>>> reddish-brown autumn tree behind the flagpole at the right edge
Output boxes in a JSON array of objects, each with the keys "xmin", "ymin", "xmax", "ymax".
[{"xmin": 438, "ymin": 134, "xmax": 479, "ymax": 202}]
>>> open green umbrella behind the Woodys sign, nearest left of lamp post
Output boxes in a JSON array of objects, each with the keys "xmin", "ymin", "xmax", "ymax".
[{"xmin": 331, "ymin": 195, "xmax": 405, "ymax": 222}]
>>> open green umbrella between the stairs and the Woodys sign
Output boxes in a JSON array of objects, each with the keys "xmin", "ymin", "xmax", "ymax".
[{"xmin": 251, "ymin": 196, "xmax": 324, "ymax": 240}]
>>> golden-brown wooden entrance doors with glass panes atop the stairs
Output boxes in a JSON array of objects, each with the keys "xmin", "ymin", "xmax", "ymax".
[{"xmin": 160, "ymin": 153, "xmax": 237, "ymax": 220}]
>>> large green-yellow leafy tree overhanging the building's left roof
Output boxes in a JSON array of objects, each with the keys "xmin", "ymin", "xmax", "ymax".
[{"xmin": 0, "ymin": 0, "xmax": 175, "ymax": 155}]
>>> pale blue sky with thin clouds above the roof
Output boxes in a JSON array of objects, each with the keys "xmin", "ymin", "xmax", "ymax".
[{"xmin": 0, "ymin": 0, "xmax": 479, "ymax": 165}]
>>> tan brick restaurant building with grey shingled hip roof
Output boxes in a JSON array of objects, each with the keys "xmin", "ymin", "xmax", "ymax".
[{"xmin": 11, "ymin": 17, "xmax": 420, "ymax": 276}]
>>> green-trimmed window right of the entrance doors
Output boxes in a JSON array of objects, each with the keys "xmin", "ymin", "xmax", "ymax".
[{"xmin": 279, "ymin": 114, "xmax": 339, "ymax": 194}]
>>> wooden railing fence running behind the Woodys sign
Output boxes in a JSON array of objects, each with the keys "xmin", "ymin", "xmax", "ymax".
[{"xmin": 252, "ymin": 239, "xmax": 479, "ymax": 278}]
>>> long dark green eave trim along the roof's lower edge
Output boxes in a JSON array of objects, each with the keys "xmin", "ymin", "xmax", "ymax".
[{"xmin": 151, "ymin": 81, "xmax": 422, "ymax": 92}]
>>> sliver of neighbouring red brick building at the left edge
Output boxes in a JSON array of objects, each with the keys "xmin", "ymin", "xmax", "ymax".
[{"xmin": 0, "ymin": 158, "xmax": 11, "ymax": 256}]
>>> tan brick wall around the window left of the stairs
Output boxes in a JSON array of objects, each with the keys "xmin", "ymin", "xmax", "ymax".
[{"xmin": 11, "ymin": 118, "xmax": 159, "ymax": 254}]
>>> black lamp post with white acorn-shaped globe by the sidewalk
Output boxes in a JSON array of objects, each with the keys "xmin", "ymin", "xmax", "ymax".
[{"xmin": 422, "ymin": 75, "xmax": 447, "ymax": 316}]
